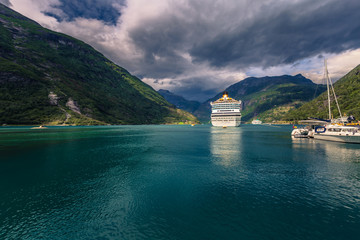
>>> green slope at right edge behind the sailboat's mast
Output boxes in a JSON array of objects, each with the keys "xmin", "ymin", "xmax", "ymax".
[{"xmin": 285, "ymin": 65, "xmax": 360, "ymax": 120}]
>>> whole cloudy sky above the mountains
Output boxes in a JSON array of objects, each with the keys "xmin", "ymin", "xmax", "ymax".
[{"xmin": 0, "ymin": 0, "xmax": 360, "ymax": 101}]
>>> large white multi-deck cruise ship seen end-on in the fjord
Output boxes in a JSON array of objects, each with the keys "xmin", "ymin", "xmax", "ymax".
[{"xmin": 210, "ymin": 92, "xmax": 241, "ymax": 127}]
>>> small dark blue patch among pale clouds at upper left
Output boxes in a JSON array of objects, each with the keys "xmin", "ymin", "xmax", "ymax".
[{"xmin": 46, "ymin": 0, "xmax": 125, "ymax": 25}]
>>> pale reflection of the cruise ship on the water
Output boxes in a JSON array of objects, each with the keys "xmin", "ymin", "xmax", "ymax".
[{"xmin": 210, "ymin": 127, "xmax": 242, "ymax": 167}]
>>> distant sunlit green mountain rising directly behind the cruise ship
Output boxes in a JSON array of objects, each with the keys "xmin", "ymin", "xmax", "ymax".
[{"xmin": 194, "ymin": 74, "xmax": 325, "ymax": 122}]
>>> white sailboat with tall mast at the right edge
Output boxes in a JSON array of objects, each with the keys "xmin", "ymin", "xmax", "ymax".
[{"xmin": 310, "ymin": 59, "xmax": 360, "ymax": 143}]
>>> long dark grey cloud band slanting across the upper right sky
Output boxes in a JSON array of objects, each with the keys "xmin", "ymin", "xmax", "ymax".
[{"xmin": 190, "ymin": 0, "xmax": 360, "ymax": 67}]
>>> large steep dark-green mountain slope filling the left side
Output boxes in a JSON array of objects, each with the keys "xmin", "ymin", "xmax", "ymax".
[{"xmin": 0, "ymin": 4, "xmax": 200, "ymax": 124}]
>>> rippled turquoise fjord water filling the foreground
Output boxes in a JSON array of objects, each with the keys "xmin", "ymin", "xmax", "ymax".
[{"xmin": 0, "ymin": 125, "xmax": 360, "ymax": 240}]
